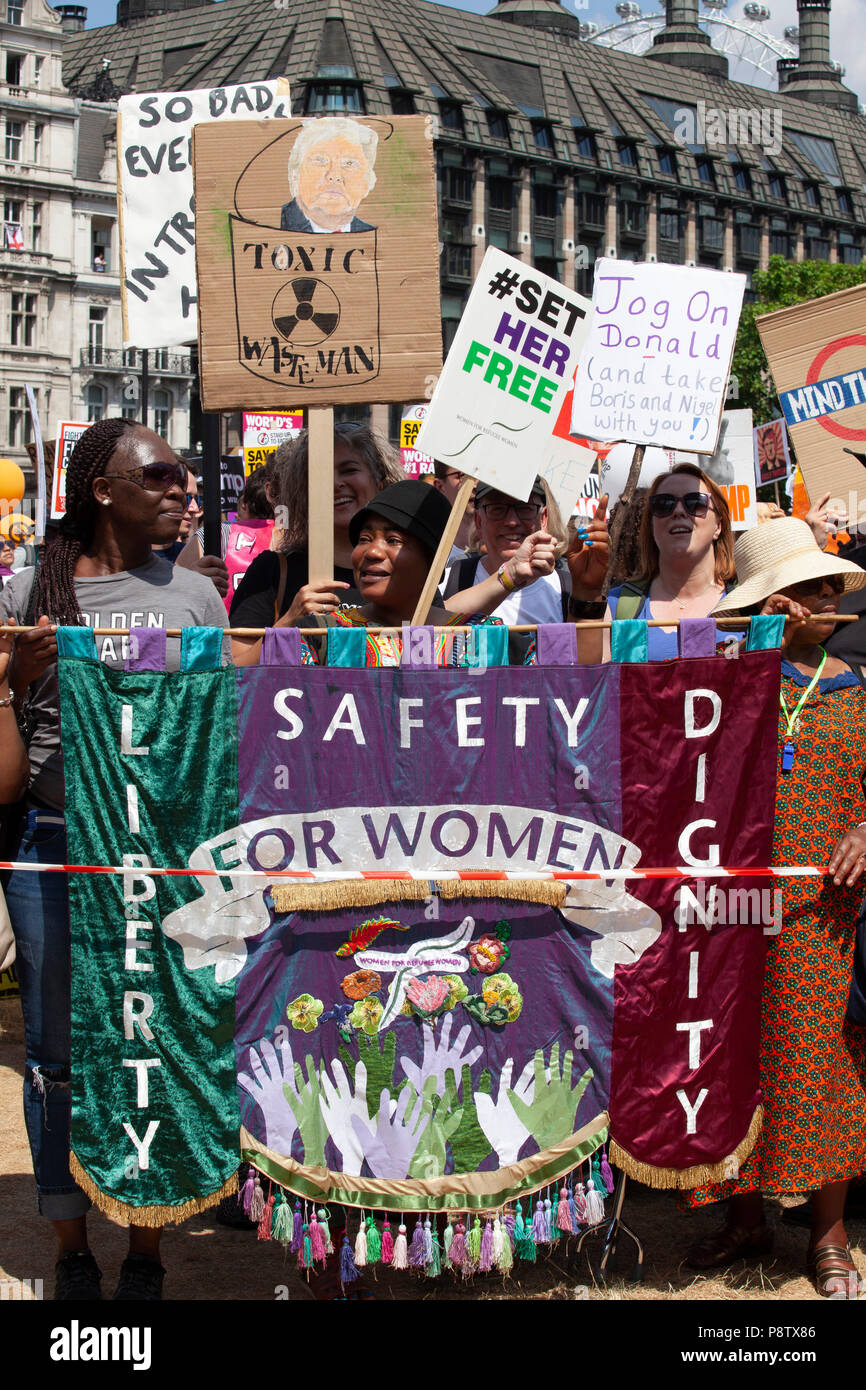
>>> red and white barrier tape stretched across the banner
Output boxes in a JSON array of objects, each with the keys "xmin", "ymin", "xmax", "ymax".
[{"xmin": 0, "ymin": 859, "xmax": 828, "ymax": 883}]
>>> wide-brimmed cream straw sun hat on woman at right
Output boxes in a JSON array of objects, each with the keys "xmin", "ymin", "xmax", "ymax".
[{"xmin": 713, "ymin": 517, "xmax": 866, "ymax": 613}]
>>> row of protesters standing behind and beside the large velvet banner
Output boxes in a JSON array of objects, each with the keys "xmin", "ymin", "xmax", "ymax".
[{"xmin": 0, "ymin": 420, "xmax": 866, "ymax": 1301}]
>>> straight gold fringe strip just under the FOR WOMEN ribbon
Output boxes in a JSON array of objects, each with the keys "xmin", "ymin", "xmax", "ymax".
[{"xmin": 271, "ymin": 878, "xmax": 567, "ymax": 912}]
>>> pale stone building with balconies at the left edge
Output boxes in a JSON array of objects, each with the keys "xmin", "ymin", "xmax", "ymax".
[{"xmin": 0, "ymin": 0, "xmax": 192, "ymax": 463}]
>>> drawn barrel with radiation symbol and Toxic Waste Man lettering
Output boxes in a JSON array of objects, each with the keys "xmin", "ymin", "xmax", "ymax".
[{"xmin": 229, "ymin": 215, "xmax": 381, "ymax": 395}]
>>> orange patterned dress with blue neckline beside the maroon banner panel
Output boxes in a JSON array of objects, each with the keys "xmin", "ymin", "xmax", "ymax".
[{"xmin": 689, "ymin": 660, "xmax": 866, "ymax": 1207}]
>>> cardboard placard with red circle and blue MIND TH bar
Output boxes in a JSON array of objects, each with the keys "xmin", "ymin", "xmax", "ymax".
[{"xmin": 756, "ymin": 285, "xmax": 866, "ymax": 505}]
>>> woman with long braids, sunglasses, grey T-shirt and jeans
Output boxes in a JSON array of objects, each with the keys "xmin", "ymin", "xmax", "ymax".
[{"xmin": 0, "ymin": 420, "xmax": 225, "ymax": 1302}]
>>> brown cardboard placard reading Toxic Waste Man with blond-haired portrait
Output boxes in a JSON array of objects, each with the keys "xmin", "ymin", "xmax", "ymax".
[{"xmin": 193, "ymin": 115, "xmax": 442, "ymax": 410}]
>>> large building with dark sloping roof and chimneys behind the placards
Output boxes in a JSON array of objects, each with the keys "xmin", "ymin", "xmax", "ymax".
[{"xmin": 0, "ymin": 0, "xmax": 866, "ymax": 455}]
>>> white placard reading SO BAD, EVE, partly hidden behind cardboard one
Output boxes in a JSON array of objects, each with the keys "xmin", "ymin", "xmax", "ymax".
[{"xmin": 117, "ymin": 78, "xmax": 291, "ymax": 348}]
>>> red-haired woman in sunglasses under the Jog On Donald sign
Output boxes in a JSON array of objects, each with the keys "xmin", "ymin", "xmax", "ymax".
[{"xmin": 567, "ymin": 463, "xmax": 734, "ymax": 662}]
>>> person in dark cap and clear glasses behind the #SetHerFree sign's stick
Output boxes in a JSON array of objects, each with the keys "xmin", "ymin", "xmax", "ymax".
[{"xmin": 442, "ymin": 478, "xmax": 570, "ymax": 624}]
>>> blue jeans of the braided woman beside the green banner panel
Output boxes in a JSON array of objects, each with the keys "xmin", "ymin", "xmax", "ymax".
[{"xmin": 6, "ymin": 809, "xmax": 90, "ymax": 1220}]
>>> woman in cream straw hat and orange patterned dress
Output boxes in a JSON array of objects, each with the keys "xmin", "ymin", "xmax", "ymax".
[{"xmin": 688, "ymin": 517, "xmax": 866, "ymax": 1298}]
